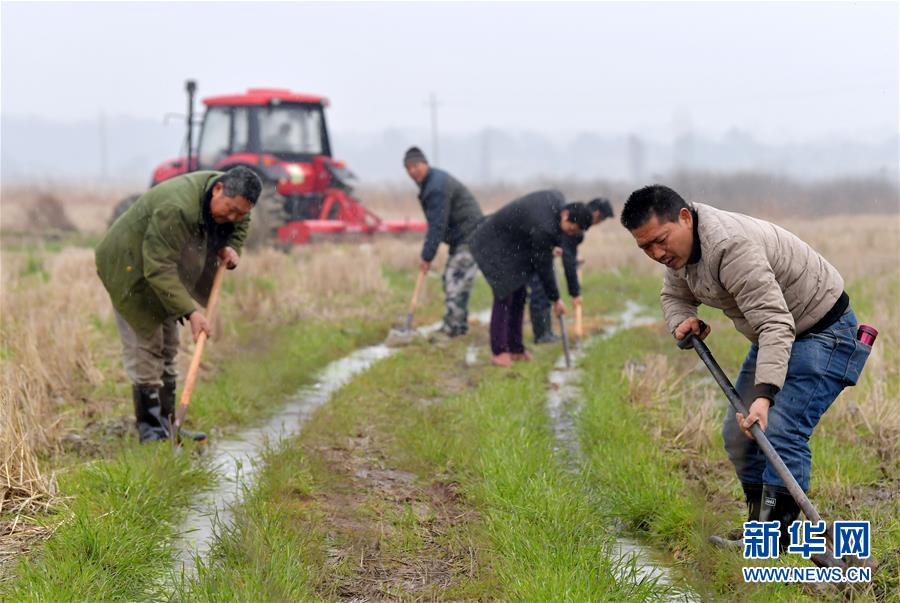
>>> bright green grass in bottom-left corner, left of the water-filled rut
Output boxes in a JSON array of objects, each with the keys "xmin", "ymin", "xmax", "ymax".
[{"xmin": 0, "ymin": 444, "xmax": 209, "ymax": 601}]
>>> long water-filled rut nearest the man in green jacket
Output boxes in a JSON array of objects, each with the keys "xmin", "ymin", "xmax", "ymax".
[{"xmin": 175, "ymin": 310, "xmax": 490, "ymax": 575}]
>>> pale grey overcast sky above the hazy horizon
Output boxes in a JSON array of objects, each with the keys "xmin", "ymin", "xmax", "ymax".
[{"xmin": 0, "ymin": 2, "xmax": 900, "ymax": 142}]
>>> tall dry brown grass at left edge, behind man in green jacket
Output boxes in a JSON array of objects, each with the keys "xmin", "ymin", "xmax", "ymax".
[{"xmin": 0, "ymin": 248, "xmax": 110, "ymax": 511}]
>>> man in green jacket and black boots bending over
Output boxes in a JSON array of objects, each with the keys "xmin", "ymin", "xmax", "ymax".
[{"xmin": 96, "ymin": 167, "xmax": 262, "ymax": 442}]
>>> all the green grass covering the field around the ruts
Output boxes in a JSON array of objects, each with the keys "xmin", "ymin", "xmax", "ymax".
[{"xmin": 10, "ymin": 254, "xmax": 900, "ymax": 601}]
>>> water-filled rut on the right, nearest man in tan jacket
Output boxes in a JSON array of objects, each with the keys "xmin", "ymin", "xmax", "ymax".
[{"xmin": 546, "ymin": 301, "xmax": 700, "ymax": 601}]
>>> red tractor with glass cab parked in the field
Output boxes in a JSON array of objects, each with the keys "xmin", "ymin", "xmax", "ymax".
[{"xmin": 114, "ymin": 81, "xmax": 426, "ymax": 245}]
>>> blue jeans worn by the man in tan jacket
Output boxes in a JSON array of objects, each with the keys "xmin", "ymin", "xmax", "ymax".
[{"xmin": 722, "ymin": 308, "xmax": 872, "ymax": 491}]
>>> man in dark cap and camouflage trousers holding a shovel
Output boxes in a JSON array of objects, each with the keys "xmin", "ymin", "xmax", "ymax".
[{"xmin": 403, "ymin": 147, "xmax": 482, "ymax": 337}]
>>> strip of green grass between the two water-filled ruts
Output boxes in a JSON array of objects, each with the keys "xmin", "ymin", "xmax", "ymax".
[{"xmin": 186, "ymin": 278, "xmax": 684, "ymax": 601}]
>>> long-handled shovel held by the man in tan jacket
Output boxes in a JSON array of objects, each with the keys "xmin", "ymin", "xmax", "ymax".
[{"xmin": 678, "ymin": 322, "xmax": 848, "ymax": 569}]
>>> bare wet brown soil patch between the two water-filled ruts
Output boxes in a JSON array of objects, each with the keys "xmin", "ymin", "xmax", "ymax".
[{"xmin": 314, "ymin": 433, "xmax": 486, "ymax": 601}]
